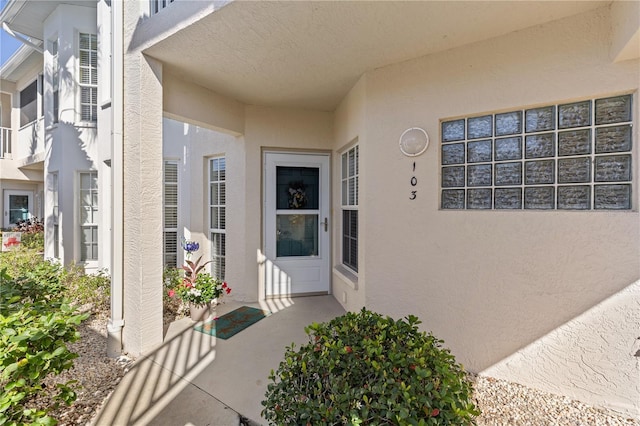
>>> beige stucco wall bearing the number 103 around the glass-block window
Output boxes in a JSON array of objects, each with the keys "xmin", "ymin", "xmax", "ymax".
[{"xmin": 352, "ymin": 8, "xmax": 640, "ymax": 415}]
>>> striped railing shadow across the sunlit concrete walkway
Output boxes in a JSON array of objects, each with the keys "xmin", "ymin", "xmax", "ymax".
[{"xmin": 92, "ymin": 319, "xmax": 228, "ymax": 425}]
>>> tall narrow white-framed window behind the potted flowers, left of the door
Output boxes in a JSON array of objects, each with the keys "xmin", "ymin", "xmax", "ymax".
[{"xmin": 209, "ymin": 157, "xmax": 227, "ymax": 280}]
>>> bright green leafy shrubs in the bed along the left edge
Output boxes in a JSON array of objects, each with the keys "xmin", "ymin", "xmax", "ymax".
[{"xmin": 0, "ymin": 235, "xmax": 109, "ymax": 425}]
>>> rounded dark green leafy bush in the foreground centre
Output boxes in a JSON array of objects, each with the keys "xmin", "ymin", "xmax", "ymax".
[{"xmin": 262, "ymin": 309, "xmax": 479, "ymax": 426}]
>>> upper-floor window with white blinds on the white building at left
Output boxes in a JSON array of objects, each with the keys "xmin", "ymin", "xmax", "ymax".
[{"xmin": 78, "ymin": 33, "xmax": 98, "ymax": 121}]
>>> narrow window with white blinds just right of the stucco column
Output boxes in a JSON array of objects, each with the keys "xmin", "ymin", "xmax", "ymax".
[{"xmin": 162, "ymin": 160, "xmax": 178, "ymax": 266}]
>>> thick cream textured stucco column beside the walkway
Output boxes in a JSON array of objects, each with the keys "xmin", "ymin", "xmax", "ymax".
[{"xmin": 121, "ymin": 2, "xmax": 163, "ymax": 355}]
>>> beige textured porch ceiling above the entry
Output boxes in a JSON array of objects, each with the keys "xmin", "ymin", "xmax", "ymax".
[{"xmin": 145, "ymin": 1, "xmax": 610, "ymax": 111}]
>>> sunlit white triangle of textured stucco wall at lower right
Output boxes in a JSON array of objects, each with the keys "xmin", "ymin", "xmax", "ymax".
[{"xmin": 482, "ymin": 281, "xmax": 640, "ymax": 416}]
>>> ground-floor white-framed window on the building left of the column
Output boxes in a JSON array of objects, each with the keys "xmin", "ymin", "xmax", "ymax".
[{"xmin": 79, "ymin": 172, "xmax": 98, "ymax": 261}]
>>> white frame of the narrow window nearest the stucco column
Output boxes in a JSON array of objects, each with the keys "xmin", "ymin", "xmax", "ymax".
[{"xmin": 162, "ymin": 160, "xmax": 180, "ymax": 267}]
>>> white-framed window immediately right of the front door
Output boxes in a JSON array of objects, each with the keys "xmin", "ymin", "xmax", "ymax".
[{"xmin": 340, "ymin": 144, "xmax": 360, "ymax": 273}]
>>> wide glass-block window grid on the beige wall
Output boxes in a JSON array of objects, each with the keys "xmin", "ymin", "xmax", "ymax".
[{"xmin": 440, "ymin": 95, "xmax": 633, "ymax": 210}]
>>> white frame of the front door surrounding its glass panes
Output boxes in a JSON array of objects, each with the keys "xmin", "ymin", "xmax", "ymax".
[{"xmin": 259, "ymin": 149, "xmax": 332, "ymax": 298}]
